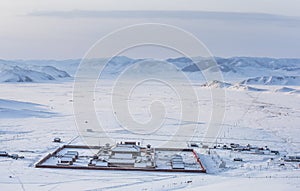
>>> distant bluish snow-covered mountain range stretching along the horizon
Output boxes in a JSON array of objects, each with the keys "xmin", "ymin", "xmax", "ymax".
[{"xmin": 0, "ymin": 56, "xmax": 300, "ymax": 85}]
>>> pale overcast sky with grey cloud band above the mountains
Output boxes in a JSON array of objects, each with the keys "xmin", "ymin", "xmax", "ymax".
[{"xmin": 0, "ymin": 0, "xmax": 300, "ymax": 59}]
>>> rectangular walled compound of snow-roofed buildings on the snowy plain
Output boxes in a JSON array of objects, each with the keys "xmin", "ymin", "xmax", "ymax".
[{"xmin": 36, "ymin": 141, "xmax": 206, "ymax": 172}]
